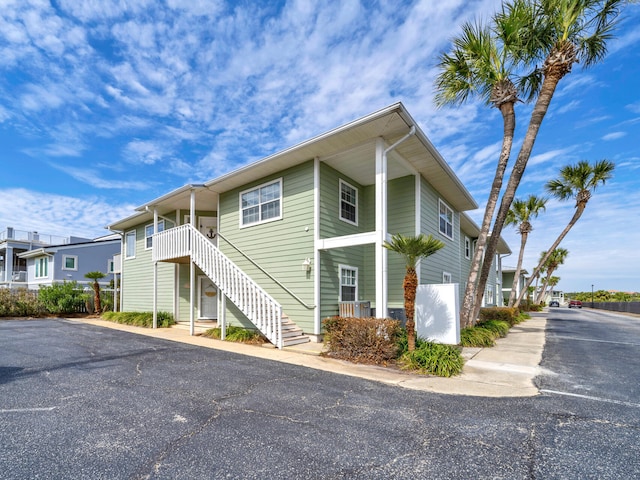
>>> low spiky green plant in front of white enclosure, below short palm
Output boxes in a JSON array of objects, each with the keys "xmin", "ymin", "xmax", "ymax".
[{"xmin": 399, "ymin": 341, "xmax": 464, "ymax": 377}]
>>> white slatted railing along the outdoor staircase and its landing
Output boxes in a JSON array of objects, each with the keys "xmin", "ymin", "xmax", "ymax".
[{"xmin": 153, "ymin": 224, "xmax": 282, "ymax": 348}]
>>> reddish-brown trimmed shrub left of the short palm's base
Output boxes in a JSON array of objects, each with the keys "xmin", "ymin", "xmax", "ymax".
[{"xmin": 323, "ymin": 317, "xmax": 402, "ymax": 365}]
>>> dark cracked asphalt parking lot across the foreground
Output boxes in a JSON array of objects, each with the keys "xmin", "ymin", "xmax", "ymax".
[{"xmin": 0, "ymin": 312, "xmax": 640, "ymax": 479}]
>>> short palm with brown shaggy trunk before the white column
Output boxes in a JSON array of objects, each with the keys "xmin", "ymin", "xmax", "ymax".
[{"xmin": 384, "ymin": 233, "xmax": 444, "ymax": 351}]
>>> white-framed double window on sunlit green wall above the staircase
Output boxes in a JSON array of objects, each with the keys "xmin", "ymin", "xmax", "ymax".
[{"xmin": 240, "ymin": 179, "xmax": 282, "ymax": 227}]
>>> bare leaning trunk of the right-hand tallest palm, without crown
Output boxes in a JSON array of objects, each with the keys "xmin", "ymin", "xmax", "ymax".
[{"xmin": 472, "ymin": 75, "xmax": 562, "ymax": 321}]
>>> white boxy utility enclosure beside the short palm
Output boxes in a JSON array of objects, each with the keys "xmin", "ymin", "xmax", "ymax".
[{"xmin": 415, "ymin": 283, "xmax": 460, "ymax": 345}]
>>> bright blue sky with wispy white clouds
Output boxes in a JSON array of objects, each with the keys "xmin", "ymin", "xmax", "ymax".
[{"xmin": 0, "ymin": 0, "xmax": 640, "ymax": 291}]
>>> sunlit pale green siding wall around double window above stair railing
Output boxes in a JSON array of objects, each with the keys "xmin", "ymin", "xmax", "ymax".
[{"xmin": 218, "ymin": 160, "xmax": 316, "ymax": 332}]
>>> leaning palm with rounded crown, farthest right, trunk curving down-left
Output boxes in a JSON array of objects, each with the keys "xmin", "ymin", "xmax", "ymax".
[{"xmin": 514, "ymin": 160, "xmax": 615, "ymax": 307}]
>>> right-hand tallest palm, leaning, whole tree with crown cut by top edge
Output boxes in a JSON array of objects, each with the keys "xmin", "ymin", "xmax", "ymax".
[{"xmin": 471, "ymin": 0, "xmax": 627, "ymax": 320}]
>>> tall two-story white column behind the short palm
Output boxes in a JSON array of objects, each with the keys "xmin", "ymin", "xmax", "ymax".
[{"xmin": 375, "ymin": 138, "xmax": 388, "ymax": 318}]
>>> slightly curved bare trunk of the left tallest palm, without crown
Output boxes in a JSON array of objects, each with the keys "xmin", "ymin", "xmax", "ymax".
[{"xmin": 460, "ymin": 102, "xmax": 516, "ymax": 328}]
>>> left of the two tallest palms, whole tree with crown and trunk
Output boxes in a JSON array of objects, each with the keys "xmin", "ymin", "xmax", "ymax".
[{"xmin": 435, "ymin": 0, "xmax": 535, "ymax": 327}]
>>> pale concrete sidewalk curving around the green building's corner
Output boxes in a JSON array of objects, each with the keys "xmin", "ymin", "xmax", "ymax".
[{"xmin": 74, "ymin": 313, "xmax": 546, "ymax": 397}]
